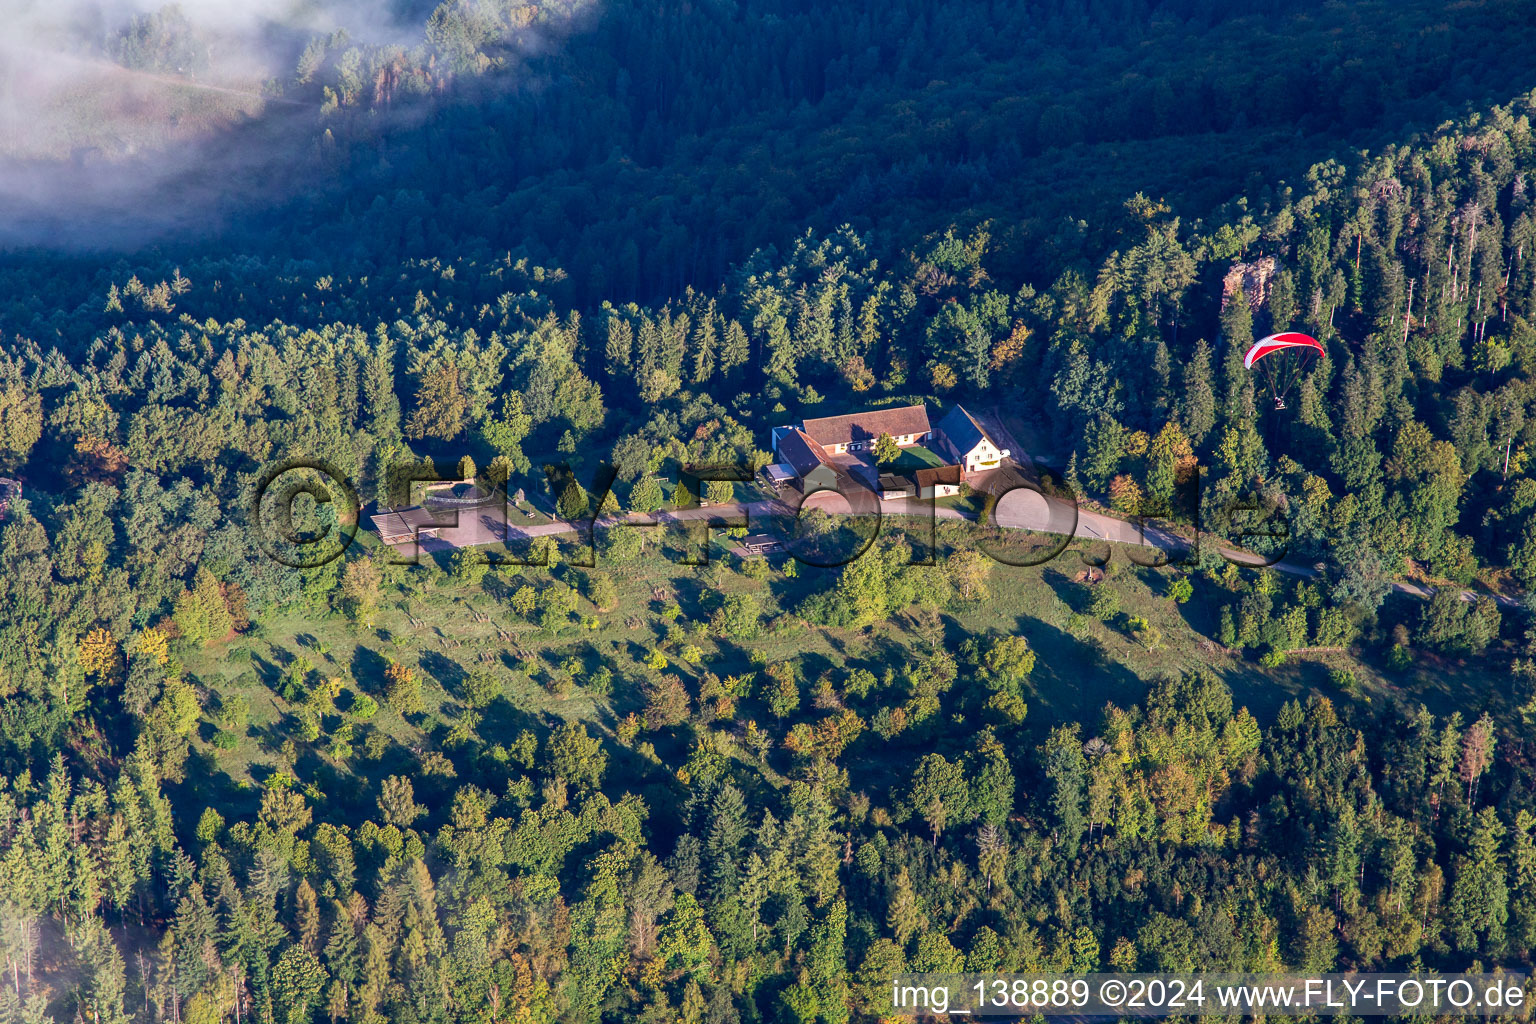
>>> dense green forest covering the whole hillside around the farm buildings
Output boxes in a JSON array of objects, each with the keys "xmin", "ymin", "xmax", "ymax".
[{"xmin": 0, "ymin": 0, "xmax": 1536, "ymax": 1024}]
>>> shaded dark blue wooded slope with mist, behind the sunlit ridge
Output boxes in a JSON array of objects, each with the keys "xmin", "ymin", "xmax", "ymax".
[{"xmin": 9, "ymin": 0, "xmax": 1533, "ymax": 268}]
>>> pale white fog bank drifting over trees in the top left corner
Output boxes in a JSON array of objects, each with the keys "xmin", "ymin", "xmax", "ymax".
[{"xmin": 0, "ymin": 0, "xmax": 580, "ymax": 249}]
